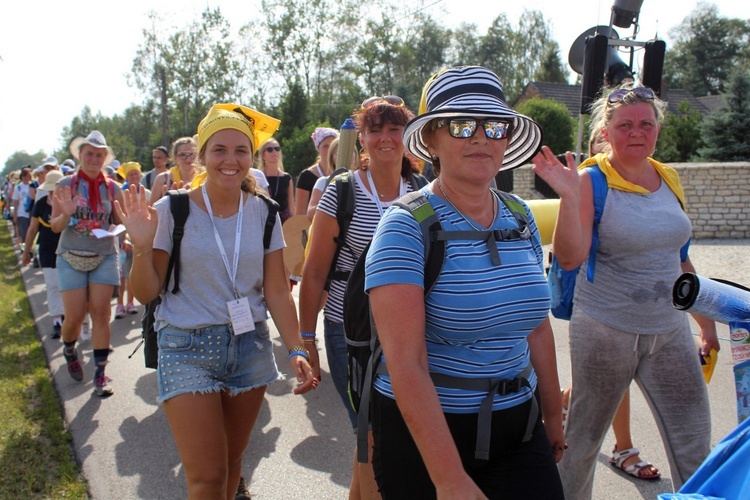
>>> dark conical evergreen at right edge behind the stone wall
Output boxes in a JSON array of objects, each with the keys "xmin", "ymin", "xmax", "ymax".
[{"xmin": 699, "ymin": 68, "xmax": 750, "ymax": 161}]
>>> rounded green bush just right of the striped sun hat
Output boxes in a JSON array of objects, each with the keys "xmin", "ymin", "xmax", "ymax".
[{"xmin": 516, "ymin": 99, "xmax": 576, "ymax": 152}]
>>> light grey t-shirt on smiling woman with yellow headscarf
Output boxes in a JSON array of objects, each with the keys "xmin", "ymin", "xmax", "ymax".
[{"xmin": 154, "ymin": 195, "xmax": 286, "ymax": 330}]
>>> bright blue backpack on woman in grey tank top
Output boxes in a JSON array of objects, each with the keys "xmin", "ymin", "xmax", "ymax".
[{"xmin": 547, "ymin": 165, "xmax": 609, "ymax": 320}]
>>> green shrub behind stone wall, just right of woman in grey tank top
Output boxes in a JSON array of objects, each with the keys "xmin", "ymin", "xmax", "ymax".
[{"xmin": 656, "ymin": 101, "xmax": 704, "ymax": 163}]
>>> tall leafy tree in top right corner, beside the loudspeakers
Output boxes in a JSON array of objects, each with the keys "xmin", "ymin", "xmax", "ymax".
[{"xmin": 664, "ymin": 2, "xmax": 750, "ymax": 95}]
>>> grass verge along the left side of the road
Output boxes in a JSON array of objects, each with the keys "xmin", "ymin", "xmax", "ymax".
[{"xmin": 0, "ymin": 227, "xmax": 88, "ymax": 498}]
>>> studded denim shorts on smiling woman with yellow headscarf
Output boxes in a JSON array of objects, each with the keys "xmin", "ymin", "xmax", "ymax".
[{"xmin": 156, "ymin": 321, "xmax": 281, "ymax": 403}]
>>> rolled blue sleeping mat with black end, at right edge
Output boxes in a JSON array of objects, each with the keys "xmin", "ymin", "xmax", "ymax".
[{"xmin": 672, "ymin": 273, "xmax": 750, "ymax": 324}]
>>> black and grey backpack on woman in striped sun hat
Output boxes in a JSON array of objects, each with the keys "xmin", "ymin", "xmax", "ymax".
[{"xmin": 344, "ymin": 189, "xmax": 538, "ymax": 463}]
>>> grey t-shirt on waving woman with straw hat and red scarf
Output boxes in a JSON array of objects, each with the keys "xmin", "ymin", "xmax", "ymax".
[{"xmin": 57, "ymin": 176, "xmax": 120, "ymax": 255}]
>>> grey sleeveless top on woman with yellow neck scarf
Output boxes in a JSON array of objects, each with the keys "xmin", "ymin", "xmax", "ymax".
[{"xmin": 574, "ymin": 182, "xmax": 691, "ymax": 334}]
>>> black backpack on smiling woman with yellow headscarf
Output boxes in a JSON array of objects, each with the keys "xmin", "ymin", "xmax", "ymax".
[{"xmin": 128, "ymin": 189, "xmax": 279, "ymax": 369}]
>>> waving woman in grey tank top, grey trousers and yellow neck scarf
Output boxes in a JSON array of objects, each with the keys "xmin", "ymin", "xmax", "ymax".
[{"xmin": 534, "ymin": 84, "xmax": 719, "ymax": 498}]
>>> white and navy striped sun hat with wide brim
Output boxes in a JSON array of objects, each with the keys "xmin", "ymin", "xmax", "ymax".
[{"xmin": 404, "ymin": 66, "xmax": 542, "ymax": 170}]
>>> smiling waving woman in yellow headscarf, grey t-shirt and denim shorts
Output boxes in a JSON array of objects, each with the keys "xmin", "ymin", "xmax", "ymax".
[{"xmin": 118, "ymin": 104, "xmax": 317, "ymax": 498}]
